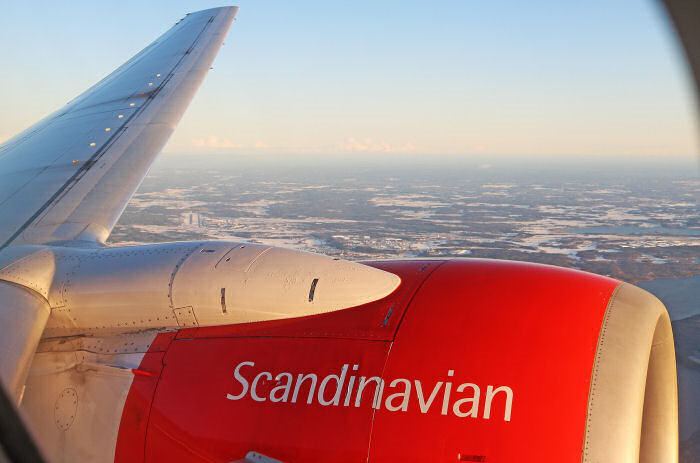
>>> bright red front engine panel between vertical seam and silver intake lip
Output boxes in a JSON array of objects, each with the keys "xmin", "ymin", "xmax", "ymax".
[{"xmin": 370, "ymin": 261, "xmax": 617, "ymax": 462}]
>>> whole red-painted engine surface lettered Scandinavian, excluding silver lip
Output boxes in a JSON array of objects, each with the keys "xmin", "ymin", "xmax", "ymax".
[{"xmin": 117, "ymin": 260, "xmax": 617, "ymax": 462}]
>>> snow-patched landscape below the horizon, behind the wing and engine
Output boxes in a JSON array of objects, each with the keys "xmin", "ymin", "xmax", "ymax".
[{"xmin": 111, "ymin": 156, "xmax": 700, "ymax": 463}]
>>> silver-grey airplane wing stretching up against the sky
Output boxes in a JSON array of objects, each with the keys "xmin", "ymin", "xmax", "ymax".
[{"xmin": 0, "ymin": 7, "xmax": 238, "ymax": 250}]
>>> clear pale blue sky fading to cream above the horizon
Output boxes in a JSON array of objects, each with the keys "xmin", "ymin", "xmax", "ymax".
[{"xmin": 0, "ymin": 0, "xmax": 700, "ymax": 162}]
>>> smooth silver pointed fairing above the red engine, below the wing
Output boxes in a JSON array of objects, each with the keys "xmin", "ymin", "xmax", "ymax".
[{"xmin": 0, "ymin": 241, "xmax": 401, "ymax": 338}]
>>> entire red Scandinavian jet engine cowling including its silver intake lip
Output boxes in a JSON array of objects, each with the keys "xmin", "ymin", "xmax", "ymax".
[{"xmin": 116, "ymin": 260, "xmax": 677, "ymax": 462}]
